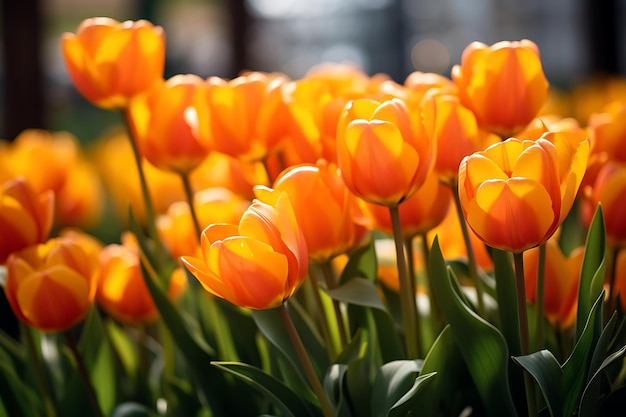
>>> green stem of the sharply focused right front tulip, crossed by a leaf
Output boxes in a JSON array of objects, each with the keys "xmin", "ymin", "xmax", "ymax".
[{"xmin": 513, "ymin": 252, "xmax": 537, "ymax": 417}]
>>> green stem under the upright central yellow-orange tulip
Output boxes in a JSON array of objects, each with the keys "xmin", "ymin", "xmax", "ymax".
[{"xmin": 389, "ymin": 206, "xmax": 420, "ymax": 359}]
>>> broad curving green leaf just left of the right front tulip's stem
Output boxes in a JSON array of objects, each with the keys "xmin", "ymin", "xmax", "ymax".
[{"xmin": 430, "ymin": 237, "xmax": 517, "ymax": 416}]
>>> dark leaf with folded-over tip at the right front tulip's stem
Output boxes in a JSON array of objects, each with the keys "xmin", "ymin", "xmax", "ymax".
[{"xmin": 513, "ymin": 349, "xmax": 565, "ymax": 417}]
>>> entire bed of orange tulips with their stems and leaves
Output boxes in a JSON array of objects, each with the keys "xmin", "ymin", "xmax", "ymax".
[{"xmin": 0, "ymin": 18, "xmax": 626, "ymax": 417}]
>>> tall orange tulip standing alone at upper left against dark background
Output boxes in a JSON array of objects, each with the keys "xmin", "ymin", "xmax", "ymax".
[{"xmin": 61, "ymin": 17, "xmax": 165, "ymax": 109}]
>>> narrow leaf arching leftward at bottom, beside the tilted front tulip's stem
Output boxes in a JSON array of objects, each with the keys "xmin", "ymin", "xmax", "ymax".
[{"xmin": 212, "ymin": 362, "xmax": 319, "ymax": 417}]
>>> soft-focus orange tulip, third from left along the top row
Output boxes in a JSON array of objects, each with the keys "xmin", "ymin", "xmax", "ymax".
[{"xmin": 207, "ymin": 72, "xmax": 288, "ymax": 161}]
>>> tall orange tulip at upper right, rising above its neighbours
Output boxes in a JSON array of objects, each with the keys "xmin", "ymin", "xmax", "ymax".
[{"xmin": 452, "ymin": 39, "xmax": 549, "ymax": 138}]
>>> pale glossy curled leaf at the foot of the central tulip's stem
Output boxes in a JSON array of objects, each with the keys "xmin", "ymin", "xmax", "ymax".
[{"xmin": 371, "ymin": 360, "xmax": 435, "ymax": 417}]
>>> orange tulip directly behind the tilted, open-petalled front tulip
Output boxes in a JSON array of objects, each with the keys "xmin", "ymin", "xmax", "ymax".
[{"xmin": 255, "ymin": 160, "xmax": 366, "ymax": 263}]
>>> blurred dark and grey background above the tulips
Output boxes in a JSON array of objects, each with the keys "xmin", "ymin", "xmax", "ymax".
[{"xmin": 0, "ymin": 0, "xmax": 626, "ymax": 142}]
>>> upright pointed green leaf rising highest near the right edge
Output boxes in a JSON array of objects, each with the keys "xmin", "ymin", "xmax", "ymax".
[{"xmin": 576, "ymin": 205, "xmax": 606, "ymax": 340}]
